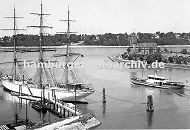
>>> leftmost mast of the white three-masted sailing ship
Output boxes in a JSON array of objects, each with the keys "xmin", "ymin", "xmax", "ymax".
[{"xmin": 1, "ymin": 6, "xmax": 25, "ymax": 80}]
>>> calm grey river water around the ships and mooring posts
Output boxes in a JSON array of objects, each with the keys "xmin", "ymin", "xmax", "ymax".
[{"xmin": 0, "ymin": 47, "xmax": 190, "ymax": 129}]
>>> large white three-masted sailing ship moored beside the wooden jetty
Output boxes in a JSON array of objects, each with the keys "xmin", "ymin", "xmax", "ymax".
[{"xmin": 2, "ymin": 2, "xmax": 94, "ymax": 101}]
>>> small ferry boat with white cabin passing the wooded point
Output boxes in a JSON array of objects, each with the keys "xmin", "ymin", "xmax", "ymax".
[{"xmin": 131, "ymin": 74, "xmax": 185, "ymax": 89}]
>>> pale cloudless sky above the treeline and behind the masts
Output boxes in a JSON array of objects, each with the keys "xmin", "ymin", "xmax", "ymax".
[{"xmin": 0, "ymin": 0, "xmax": 190, "ymax": 36}]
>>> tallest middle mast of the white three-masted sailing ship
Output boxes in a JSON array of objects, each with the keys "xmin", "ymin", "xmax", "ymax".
[{"xmin": 28, "ymin": 0, "xmax": 52, "ymax": 104}]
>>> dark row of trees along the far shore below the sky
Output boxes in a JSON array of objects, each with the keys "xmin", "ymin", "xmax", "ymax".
[{"xmin": 0, "ymin": 32, "xmax": 190, "ymax": 46}]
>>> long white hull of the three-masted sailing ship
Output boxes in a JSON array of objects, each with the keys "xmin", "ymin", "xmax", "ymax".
[{"xmin": 2, "ymin": 80, "xmax": 93, "ymax": 101}]
